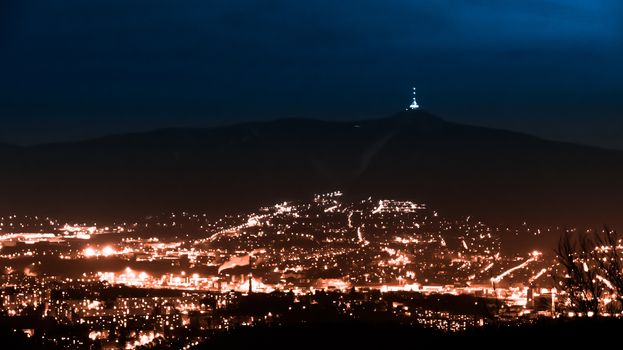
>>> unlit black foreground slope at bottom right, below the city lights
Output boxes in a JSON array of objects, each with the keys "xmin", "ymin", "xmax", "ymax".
[{"xmin": 196, "ymin": 319, "xmax": 622, "ymax": 349}]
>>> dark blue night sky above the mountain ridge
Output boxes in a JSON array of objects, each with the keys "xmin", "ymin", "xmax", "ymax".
[{"xmin": 0, "ymin": 0, "xmax": 623, "ymax": 148}]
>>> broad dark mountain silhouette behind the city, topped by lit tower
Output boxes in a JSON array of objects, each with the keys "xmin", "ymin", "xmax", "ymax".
[{"xmin": 0, "ymin": 111, "xmax": 623, "ymax": 227}]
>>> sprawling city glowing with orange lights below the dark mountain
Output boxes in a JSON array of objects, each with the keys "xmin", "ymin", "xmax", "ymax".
[{"xmin": 0, "ymin": 191, "xmax": 621, "ymax": 349}]
